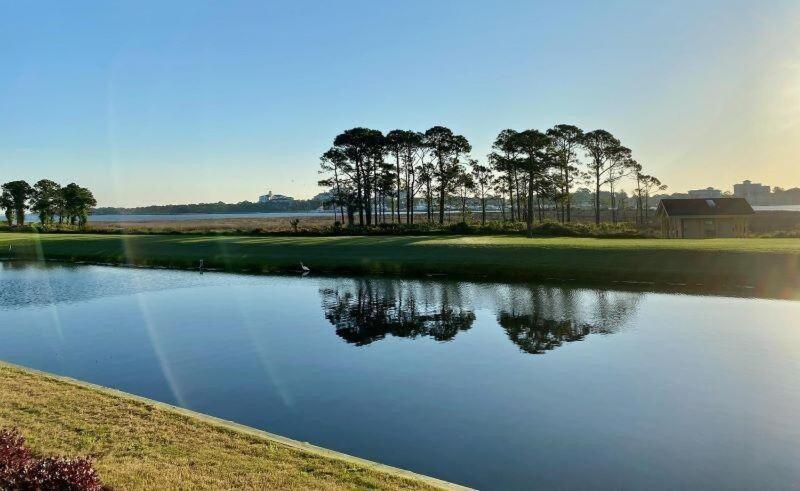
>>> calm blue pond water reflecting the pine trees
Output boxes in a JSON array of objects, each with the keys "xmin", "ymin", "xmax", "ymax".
[{"xmin": 0, "ymin": 263, "xmax": 800, "ymax": 489}]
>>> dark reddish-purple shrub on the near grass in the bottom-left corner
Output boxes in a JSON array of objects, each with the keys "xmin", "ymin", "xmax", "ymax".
[{"xmin": 0, "ymin": 428, "xmax": 102, "ymax": 491}]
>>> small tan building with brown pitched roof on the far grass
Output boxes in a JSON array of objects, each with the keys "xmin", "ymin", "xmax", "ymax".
[{"xmin": 656, "ymin": 198, "xmax": 754, "ymax": 239}]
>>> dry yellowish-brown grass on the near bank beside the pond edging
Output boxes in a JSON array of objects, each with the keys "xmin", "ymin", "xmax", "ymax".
[{"xmin": 0, "ymin": 363, "xmax": 456, "ymax": 489}]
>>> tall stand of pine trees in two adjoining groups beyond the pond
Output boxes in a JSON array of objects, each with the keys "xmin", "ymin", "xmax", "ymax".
[{"xmin": 319, "ymin": 124, "xmax": 666, "ymax": 235}]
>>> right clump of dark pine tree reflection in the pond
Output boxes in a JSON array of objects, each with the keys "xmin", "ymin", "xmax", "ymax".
[{"xmin": 496, "ymin": 286, "xmax": 642, "ymax": 354}]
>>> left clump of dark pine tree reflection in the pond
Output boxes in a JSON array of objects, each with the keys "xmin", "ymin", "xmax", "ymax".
[{"xmin": 320, "ymin": 279, "xmax": 475, "ymax": 346}]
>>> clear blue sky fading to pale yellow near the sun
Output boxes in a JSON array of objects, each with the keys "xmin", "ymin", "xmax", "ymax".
[{"xmin": 0, "ymin": 0, "xmax": 800, "ymax": 206}]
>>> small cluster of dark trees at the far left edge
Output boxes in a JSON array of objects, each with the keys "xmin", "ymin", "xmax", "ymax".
[{"xmin": 0, "ymin": 179, "xmax": 97, "ymax": 227}]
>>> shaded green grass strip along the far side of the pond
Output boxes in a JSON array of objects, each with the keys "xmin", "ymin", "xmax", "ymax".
[{"xmin": 0, "ymin": 233, "xmax": 800, "ymax": 289}]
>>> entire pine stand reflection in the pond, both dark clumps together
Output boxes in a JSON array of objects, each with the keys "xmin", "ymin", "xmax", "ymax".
[{"xmin": 319, "ymin": 278, "xmax": 642, "ymax": 354}]
